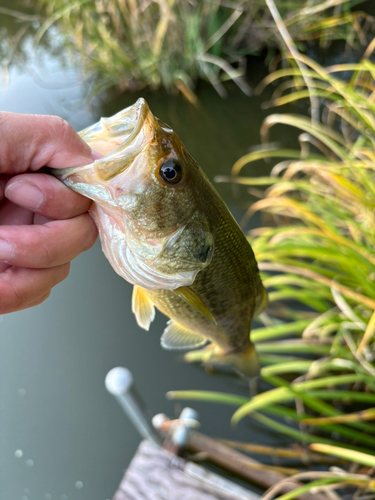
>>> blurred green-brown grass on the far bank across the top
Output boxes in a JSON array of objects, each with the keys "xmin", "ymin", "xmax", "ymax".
[{"xmin": 30, "ymin": 0, "xmax": 371, "ymax": 98}]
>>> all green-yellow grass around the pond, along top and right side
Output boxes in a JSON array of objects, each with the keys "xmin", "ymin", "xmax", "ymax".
[{"xmin": 0, "ymin": 0, "xmax": 375, "ymax": 500}]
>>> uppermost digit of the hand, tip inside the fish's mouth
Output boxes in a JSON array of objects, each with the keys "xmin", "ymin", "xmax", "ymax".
[{"xmin": 0, "ymin": 111, "xmax": 92, "ymax": 174}]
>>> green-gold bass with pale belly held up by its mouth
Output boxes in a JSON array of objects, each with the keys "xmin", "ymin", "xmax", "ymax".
[{"xmin": 51, "ymin": 98, "xmax": 267, "ymax": 378}]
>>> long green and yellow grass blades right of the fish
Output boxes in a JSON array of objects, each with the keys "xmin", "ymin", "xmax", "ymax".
[{"xmin": 169, "ymin": 41, "xmax": 375, "ymax": 500}]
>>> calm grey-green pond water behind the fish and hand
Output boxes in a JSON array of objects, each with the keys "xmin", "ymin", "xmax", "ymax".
[{"xmin": 0, "ymin": 6, "xmax": 300, "ymax": 500}]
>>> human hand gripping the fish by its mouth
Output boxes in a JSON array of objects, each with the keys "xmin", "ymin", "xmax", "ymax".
[{"xmin": 0, "ymin": 112, "xmax": 97, "ymax": 314}]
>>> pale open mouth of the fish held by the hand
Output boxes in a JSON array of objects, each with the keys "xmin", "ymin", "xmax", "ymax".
[{"xmin": 48, "ymin": 97, "xmax": 154, "ymax": 181}]
